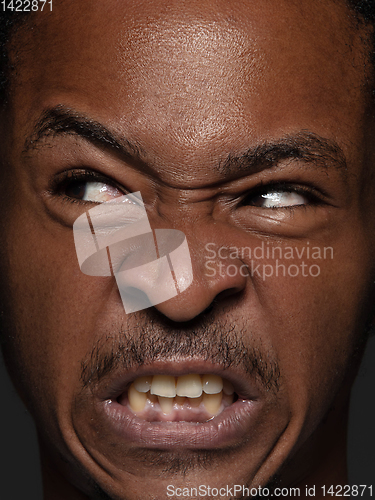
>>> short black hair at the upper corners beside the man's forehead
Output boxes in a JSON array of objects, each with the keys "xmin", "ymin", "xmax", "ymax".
[{"xmin": 0, "ymin": 0, "xmax": 375, "ymax": 105}]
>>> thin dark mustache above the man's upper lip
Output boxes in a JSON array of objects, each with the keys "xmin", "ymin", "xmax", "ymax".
[{"xmin": 81, "ymin": 319, "xmax": 280, "ymax": 392}]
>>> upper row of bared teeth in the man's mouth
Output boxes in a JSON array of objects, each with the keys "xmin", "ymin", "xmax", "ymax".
[{"xmin": 134, "ymin": 374, "xmax": 234, "ymax": 398}]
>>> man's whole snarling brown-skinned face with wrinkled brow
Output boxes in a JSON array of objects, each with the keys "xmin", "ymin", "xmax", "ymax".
[{"xmin": 1, "ymin": 0, "xmax": 375, "ymax": 499}]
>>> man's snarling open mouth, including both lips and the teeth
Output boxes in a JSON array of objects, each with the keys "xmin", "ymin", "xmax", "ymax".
[{"xmin": 92, "ymin": 361, "xmax": 267, "ymax": 450}]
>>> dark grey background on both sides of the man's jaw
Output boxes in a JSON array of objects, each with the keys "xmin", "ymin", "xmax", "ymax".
[{"xmin": 0, "ymin": 338, "xmax": 375, "ymax": 500}]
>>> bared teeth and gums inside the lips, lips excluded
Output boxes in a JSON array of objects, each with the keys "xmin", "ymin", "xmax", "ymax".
[{"xmin": 118, "ymin": 373, "xmax": 238, "ymax": 422}]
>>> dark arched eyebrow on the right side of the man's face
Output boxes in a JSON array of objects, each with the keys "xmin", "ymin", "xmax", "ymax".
[{"xmin": 218, "ymin": 131, "xmax": 347, "ymax": 177}]
